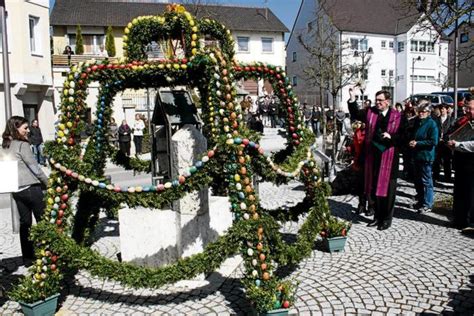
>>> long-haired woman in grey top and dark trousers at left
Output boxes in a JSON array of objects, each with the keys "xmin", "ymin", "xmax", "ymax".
[{"xmin": 2, "ymin": 116, "xmax": 48, "ymax": 266}]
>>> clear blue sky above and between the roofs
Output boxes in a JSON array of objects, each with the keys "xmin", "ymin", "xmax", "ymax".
[{"xmin": 49, "ymin": 0, "xmax": 301, "ymax": 33}]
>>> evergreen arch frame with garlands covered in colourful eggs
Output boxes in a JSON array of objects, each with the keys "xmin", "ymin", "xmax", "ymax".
[{"xmin": 14, "ymin": 5, "xmax": 330, "ymax": 311}]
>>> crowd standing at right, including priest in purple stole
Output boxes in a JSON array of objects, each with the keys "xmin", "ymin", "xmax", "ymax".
[{"xmin": 348, "ymin": 89, "xmax": 474, "ymax": 233}]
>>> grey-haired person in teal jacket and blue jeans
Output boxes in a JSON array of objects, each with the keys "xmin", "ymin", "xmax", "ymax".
[{"xmin": 408, "ymin": 100, "xmax": 438, "ymax": 213}]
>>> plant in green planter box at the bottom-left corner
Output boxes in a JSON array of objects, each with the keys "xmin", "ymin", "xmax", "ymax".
[{"xmin": 8, "ymin": 266, "xmax": 59, "ymax": 316}]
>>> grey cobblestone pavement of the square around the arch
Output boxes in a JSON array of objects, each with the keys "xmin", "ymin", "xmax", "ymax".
[{"xmin": 0, "ymin": 130, "xmax": 474, "ymax": 315}]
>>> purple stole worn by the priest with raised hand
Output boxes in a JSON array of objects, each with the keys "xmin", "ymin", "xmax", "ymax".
[{"xmin": 364, "ymin": 108, "xmax": 401, "ymax": 197}]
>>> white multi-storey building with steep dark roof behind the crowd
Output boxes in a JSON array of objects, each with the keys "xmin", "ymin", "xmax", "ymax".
[{"xmin": 287, "ymin": 0, "xmax": 448, "ymax": 106}]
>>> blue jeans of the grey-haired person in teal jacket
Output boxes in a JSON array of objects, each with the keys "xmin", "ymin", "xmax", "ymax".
[{"xmin": 415, "ymin": 161, "xmax": 434, "ymax": 209}]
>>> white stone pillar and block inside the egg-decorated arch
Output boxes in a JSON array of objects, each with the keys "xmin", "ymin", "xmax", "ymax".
[{"xmin": 119, "ymin": 125, "xmax": 232, "ymax": 270}]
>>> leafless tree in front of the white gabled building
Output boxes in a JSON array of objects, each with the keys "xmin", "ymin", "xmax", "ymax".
[{"xmin": 297, "ymin": 1, "xmax": 362, "ymax": 161}]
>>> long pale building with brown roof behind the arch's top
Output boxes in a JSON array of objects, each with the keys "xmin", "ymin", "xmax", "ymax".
[{"xmin": 51, "ymin": 0, "xmax": 289, "ymax": 127}]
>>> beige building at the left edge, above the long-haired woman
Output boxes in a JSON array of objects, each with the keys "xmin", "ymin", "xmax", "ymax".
[{"xmin": 0, "ymin": 0, "xmax": 55, "ymax": 139}]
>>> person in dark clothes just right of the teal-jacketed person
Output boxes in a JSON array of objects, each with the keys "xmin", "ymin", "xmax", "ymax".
[{"xmin": 433, "ymin": 103, "xmax": 454, "ymax": 182}]
